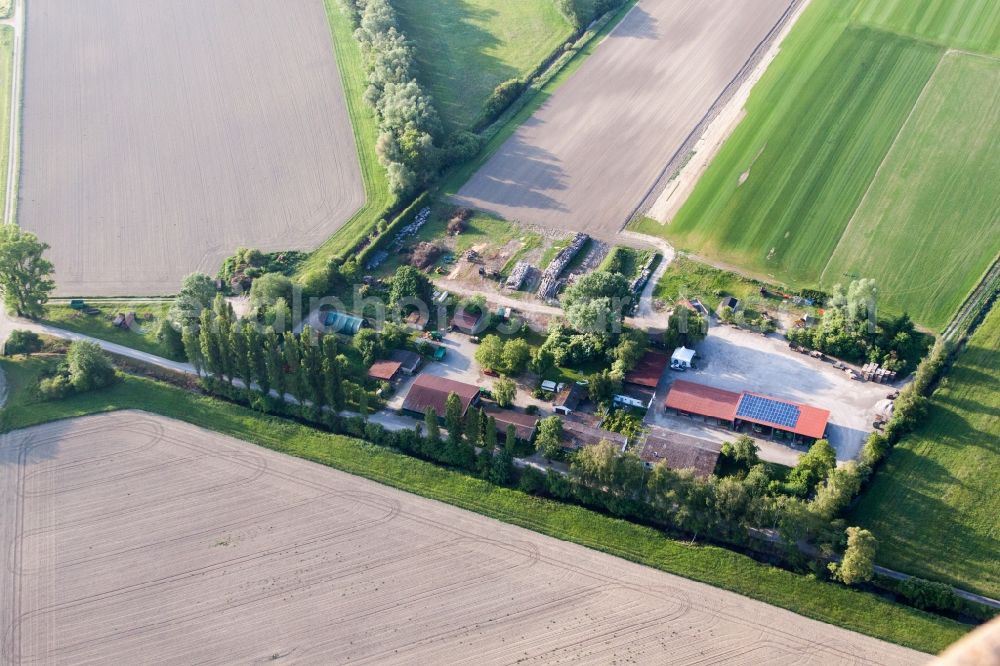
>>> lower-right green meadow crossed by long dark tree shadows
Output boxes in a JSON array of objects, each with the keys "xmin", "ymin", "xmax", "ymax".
[{"xmin": 850, "ymin": 306, "xmax": 1000, "ymax": 598}]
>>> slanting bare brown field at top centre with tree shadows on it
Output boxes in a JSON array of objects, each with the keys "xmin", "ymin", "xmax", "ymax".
[{"xmin": 455, "ymin": 0, "xmax": 797, "ymax": 239}]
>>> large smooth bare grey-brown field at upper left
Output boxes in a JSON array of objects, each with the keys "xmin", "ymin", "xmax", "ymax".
[{"xmin": 18, "ymin": 0, "xmax": 364, "ymax": 296}]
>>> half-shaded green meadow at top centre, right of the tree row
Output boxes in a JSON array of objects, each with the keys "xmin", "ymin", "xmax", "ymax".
[{"xmin": 393, "ymin": 0, "xmax": 572, "ymax": 130}]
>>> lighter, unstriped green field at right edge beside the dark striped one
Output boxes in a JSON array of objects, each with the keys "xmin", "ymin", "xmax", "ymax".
[{"xmin": 822, "ymin": 52, "xmax": 1000, "ymax": 329}]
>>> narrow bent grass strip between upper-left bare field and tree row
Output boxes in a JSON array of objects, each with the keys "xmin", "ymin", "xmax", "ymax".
[{"xmin": 298, "ymin": 0, "xmax": 393, "ymax": 275}]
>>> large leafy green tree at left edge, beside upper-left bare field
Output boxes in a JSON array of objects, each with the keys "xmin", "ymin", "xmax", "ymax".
[{"xmin": 0, "ymin": 224, "xmax": 55, "ymax": 319}]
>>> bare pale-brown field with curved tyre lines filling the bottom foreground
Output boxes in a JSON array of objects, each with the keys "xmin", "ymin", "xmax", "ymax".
[{"xmin": 0, "ymin": 412, "xmax": 926, "ymax": 665}]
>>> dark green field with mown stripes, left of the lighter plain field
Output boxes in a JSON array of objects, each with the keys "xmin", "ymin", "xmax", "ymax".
[{"xmin": 640, "ymin": 20, "xmax": 941, "ymax": 283}]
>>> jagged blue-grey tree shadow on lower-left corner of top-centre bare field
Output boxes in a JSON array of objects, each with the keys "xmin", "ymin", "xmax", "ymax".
[{"xmin": 458, "ymin": 123, "xmax": 568, "ymax": 212}]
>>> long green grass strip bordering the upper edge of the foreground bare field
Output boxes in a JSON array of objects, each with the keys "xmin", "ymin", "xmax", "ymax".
[{"xmin": 0, "ymin": 359, "xmax": 967, "ymax": 652}]
